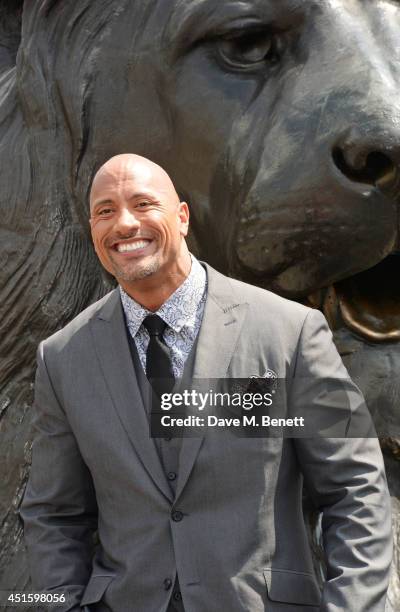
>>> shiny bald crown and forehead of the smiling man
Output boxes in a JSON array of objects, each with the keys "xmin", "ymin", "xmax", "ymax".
[{"xmin": 90, "ymin": 153, "xmax": 179, "ymax": 210}]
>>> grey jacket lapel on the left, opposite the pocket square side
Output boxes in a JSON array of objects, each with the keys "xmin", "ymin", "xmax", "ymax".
[{"xmin": 91, "ymin": 289, "xmax": 172, "ymax": 502}]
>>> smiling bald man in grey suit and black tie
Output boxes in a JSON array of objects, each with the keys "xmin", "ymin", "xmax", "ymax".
[{"xmin": 21, "ymin": 155, "xmax": 391, "ymax": 612}]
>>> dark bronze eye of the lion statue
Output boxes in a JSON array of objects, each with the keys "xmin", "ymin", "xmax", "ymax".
[{"xmin": 218, "ymin": 32, "xmax": 276, "ymax": 69}]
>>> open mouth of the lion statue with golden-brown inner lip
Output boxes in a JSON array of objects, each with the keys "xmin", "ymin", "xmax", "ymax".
[{"xmin": 307, "ymin": 253, "xmax": 400, "ymax": 342}]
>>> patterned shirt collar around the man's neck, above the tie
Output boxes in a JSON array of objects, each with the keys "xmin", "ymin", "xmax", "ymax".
[{"xmin": 119, "ymin": 255, "xmax": 207, "ymax": 336}]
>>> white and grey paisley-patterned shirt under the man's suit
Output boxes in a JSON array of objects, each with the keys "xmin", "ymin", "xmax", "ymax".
[{"xmin": 119, "ymin": 255, "xmax": 207, "ymax": 378}]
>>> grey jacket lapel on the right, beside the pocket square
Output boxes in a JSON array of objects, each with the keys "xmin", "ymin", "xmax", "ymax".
[{"xmin": 176, "ymin": 264, "xmax": 248, "ymax": 498}]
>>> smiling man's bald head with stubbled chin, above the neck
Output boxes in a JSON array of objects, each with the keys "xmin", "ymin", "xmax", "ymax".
[{"xmin": 90, "ymin": 155, "xmax": 190, "ymax": 293}]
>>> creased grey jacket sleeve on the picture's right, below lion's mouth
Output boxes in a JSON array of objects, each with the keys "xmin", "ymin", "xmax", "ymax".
[{"xmin": 292, "ymin": 310, "xmax": 392, "ymax": 612}]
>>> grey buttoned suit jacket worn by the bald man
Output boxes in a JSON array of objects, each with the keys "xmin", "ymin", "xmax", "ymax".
[{"xmin": 21, "ymin": 266, "xmax": 392, "ymax": 612}]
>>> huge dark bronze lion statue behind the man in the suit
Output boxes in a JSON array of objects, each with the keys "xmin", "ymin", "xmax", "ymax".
[{"xmin": 0, "ymin": 0, "xmax": 400, "ymax": 609}]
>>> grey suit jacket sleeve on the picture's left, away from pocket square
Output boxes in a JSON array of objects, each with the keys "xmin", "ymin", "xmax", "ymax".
[{"xmin": 20, "ymin": 343, "xmax": 97, "ymax": 612}]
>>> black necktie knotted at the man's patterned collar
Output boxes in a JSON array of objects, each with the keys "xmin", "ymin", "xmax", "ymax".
[{"xmin": 143, "ymin": 315, "xmax": 175, "ymax": 396}]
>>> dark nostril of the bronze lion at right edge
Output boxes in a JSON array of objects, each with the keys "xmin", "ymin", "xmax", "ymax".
[{"xmin": 332, "ymin": 134, "xmax": 400, "ymax": 189}]
